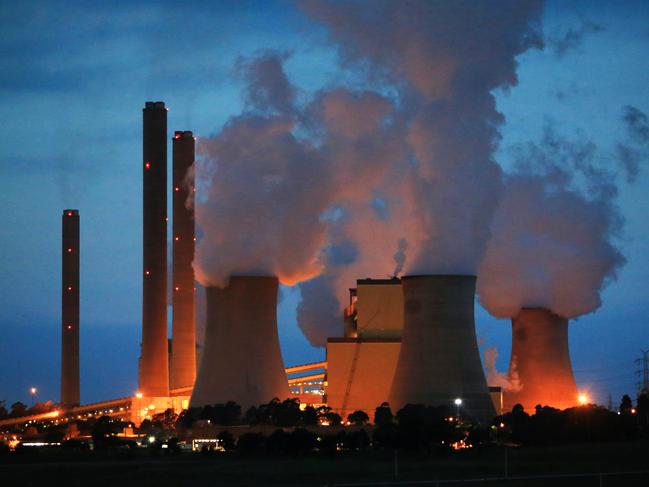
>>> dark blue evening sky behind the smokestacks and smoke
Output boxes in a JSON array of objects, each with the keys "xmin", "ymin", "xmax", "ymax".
[{"xmin": 0, "ymin": 1, "xmax": 649, "ymax": 403}]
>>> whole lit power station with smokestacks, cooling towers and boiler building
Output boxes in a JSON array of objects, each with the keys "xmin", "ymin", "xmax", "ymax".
[{"xmin": 53, "ymin": 101, "xmax": 577, "ymax": 423}]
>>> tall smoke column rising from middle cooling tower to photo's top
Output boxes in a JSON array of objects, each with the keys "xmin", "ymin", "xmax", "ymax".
[{"xmin": 301, "ymin": 1, "xmax": 542, "ymax": 273}]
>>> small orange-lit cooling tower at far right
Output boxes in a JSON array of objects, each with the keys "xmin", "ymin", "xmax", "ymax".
[{"xmin": 505, "ymin": 308, "xmax": 578, "ymax": 412}]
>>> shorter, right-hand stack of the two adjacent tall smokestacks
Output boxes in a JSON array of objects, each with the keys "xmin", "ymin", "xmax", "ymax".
[{"xmin": 171, "ymin": 131, "xmax": 196, "ymax": 389}]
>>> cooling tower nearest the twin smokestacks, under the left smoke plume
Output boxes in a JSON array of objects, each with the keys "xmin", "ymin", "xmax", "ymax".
[{"xmin": 190, "ymin": 276, "xmax": 289, "ymax": 411}]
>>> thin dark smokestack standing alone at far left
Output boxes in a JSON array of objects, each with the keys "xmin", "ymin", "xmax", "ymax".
[{"xmin": 61, "ymin": 210, "xmax": 80, "ymax": 408}]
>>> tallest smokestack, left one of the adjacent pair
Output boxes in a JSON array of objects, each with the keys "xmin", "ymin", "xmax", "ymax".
[{"xmin": 140, "ymin": 101, "xmax": 169, "ymax": 396}]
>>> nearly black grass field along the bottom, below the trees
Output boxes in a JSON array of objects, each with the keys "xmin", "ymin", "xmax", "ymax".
[{"xmin": 0, "ymin": 441, "xmax": 649, "ymax": 487}]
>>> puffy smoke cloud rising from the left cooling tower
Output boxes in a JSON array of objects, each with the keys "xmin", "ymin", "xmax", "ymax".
[{"xmin": 194, "ymin": 53, "xmax": 332, "ymax": 286}]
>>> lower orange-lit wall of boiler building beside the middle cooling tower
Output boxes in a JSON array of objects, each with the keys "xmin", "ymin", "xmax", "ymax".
[{"xmin": 326, "ymin": 338, "xmax": 401, "ymax": 420}]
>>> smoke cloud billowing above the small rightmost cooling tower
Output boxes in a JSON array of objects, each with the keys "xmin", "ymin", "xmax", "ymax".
[{"xmin": 478, "ymin": 122, "xmax": 625, "ymax": 318}]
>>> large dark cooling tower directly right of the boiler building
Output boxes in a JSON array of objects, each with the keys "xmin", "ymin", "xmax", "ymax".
[{"xmin": 389, "ymin": 275, "xmax": 495, "ymax": 421}]
